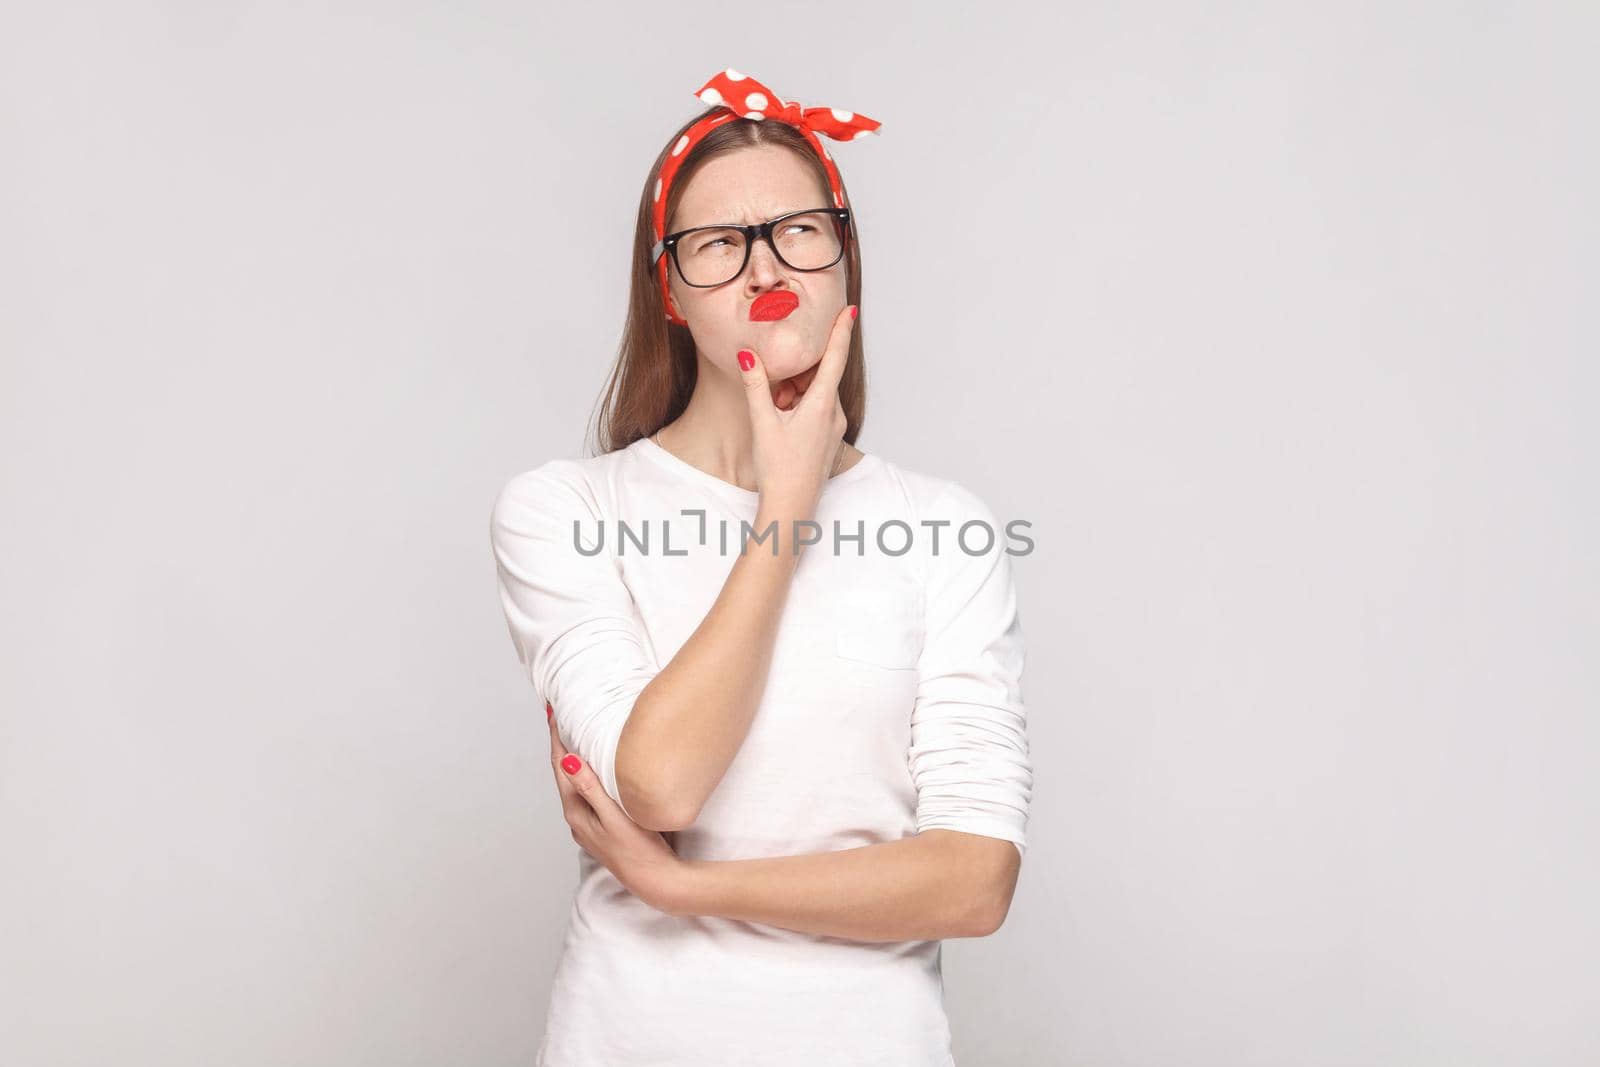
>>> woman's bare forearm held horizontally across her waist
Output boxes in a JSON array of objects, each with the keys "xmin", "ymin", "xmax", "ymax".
[{"xmin": 672, "ymin": 832, "xmax": 987, "ymax": 941}]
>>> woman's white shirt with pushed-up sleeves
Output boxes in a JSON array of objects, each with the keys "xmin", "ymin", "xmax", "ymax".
[{"xmin": 491, "ymin": 438, "xmax": 1032, "ymax": 1067}]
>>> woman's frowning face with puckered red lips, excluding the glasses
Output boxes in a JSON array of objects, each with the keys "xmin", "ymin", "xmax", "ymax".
[{"xmin": 667, "ymin": 144, "xmax": 848, "ymax": 386}]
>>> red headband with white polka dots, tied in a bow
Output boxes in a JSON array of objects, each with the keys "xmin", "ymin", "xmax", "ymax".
[{"xmin": 651, "ymin": 67, "xmax": 883, "ymax": 326}]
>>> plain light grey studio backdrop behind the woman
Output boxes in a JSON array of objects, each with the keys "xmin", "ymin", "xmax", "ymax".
[{"xmin": 0, "ymin": 2, "xmax": 1600, "ymax": 1067}]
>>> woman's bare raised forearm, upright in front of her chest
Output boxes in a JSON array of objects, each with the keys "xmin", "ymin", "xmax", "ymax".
[{"xmin": 616, "ymin": 499, "xmax": 805, "ymax": 830}]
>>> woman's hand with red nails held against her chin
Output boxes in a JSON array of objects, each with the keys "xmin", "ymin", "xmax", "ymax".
[{"xmin": 739, "ymin": 306, "xmax": 856, "ymax": 517}]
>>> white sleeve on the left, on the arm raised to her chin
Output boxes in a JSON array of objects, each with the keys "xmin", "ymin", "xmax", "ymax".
[{"xmin": 490, "ymin": 459, "xmax": 659, "ymax": 817}]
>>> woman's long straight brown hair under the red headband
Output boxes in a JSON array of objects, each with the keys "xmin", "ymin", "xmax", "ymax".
[{"xmin": 592, "ymin": 109, "xmax": 867, "ymax": 454}]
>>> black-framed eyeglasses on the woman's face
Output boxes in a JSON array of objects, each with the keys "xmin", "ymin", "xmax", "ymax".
[{"xmin": 650, "ymin": 208, "xmax": 850, "ymax": 290}]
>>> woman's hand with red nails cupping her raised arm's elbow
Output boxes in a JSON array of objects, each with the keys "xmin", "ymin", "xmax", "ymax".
[{"xmin": 544, "ymin": 704, "xmax": 683, "ymax": 915}]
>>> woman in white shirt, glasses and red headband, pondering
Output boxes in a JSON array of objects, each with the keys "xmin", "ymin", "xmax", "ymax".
[{"xmin": 491, "ymin": 70, "xmax": 1032, "ymax": 1067}]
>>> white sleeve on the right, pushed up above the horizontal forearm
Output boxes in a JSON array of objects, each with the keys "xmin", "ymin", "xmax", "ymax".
[{"xmin": 909, "ymin": 482, "xmax": 1034, "ymax": 854}]
